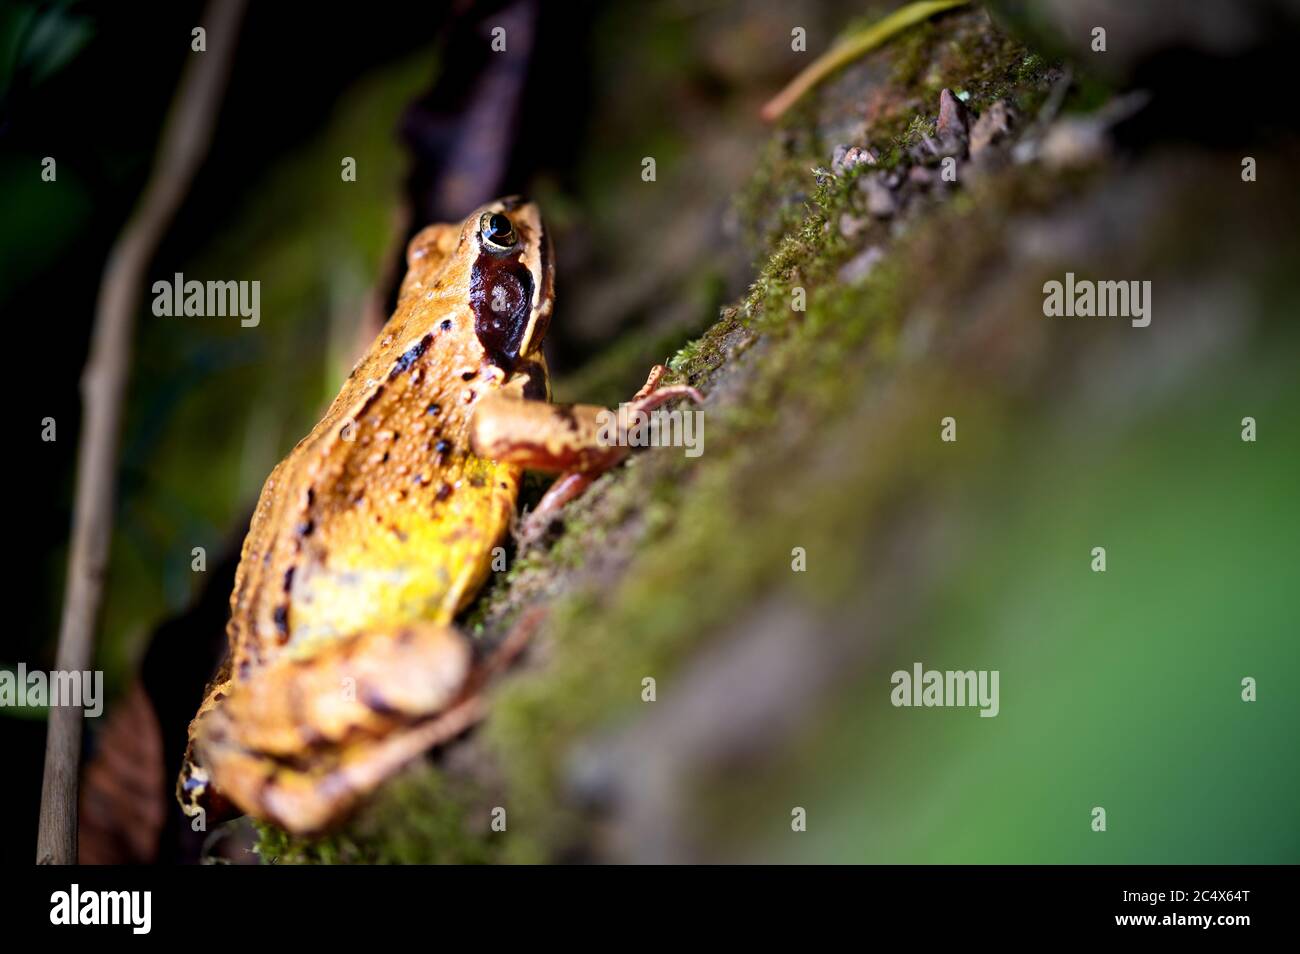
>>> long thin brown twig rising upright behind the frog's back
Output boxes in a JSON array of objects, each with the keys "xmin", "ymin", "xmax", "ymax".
[{"xmin": 36, "ymin": 0, "xmax": 244, "ymax": 864}]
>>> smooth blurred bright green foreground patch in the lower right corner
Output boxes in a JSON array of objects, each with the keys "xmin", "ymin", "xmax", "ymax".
[{"xmin": 748, "ymin": 344, "xmax": 1300, "ymax": 863}]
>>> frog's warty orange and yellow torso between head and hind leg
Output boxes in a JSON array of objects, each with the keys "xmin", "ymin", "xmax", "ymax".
[{"xmin": 230, "ymin": 246, "xmax": 520, "ymax": 672}]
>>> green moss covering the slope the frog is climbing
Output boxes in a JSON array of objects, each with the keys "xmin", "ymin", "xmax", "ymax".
[{"xmin": 253, "ymin": 5, "xmax": 1067, "ymax": 862}]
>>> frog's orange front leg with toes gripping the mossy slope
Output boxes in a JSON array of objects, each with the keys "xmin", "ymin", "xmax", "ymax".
[{"xmin": 471, "ymin": 364, "xmax": 703, "ymax": 539}]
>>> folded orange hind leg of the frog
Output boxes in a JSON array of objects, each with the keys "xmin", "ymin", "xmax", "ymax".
[{"xmin": 182, "ymin": 623, "xmax": 481, "ymax": 833}]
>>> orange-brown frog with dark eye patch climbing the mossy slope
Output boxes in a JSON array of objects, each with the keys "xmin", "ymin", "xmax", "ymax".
[{"xmin": 177, "ymin": 196, "xmax": 703, "ymax": 834}]
